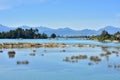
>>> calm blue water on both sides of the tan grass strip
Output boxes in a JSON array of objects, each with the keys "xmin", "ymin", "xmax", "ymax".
[{"xmin": 0, "ymin": 39, "xmax": 120, "ymax": 80}]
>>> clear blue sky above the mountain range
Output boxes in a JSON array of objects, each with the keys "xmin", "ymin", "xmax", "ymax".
[{"xmin": 0, "ymin": 0, "xmax": 120, "ymax": 30}]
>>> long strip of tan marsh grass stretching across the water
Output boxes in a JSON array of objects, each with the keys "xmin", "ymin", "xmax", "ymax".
[{"xmin": 0, "ymin": 42, "xmax": 120, "ymax": 49}]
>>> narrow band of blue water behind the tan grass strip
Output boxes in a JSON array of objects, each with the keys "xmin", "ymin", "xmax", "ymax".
[{"xmin": 0, "ymin": 38, "xmax": 120, "ymax": 46}]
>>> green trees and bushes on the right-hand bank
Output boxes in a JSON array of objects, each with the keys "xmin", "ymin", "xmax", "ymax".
[{"xmin": 91, "ymin": 30, "xmax": 120, "ymax": 41}]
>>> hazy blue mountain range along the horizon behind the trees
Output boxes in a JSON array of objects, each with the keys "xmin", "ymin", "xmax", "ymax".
[{"xmin": 0, "ymin": 24, "xmax": 120, "ymax": 36}]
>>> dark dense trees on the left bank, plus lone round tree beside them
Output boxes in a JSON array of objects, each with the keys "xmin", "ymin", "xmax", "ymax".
[{"xmin": 0, "ymin": 28, "xmax": 56, "ymax": 39}]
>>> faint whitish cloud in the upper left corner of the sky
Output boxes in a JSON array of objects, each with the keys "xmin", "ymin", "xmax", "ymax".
[{"xmin": 0, "ymin": 0, "xmax": 47, "ymax": 10}]
